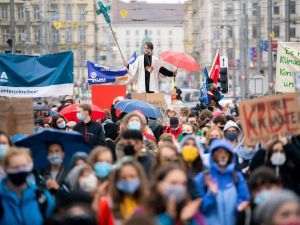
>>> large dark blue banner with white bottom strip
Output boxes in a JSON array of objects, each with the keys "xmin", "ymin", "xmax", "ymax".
[{"xmin": 0, "ymin": 52, "xmax": 73, "ymax": 97}]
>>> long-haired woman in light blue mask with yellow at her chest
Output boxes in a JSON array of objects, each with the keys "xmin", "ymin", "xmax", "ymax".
[{"xmin": 98, "ymin": 158, "xmax": 148, "ymax": 225}]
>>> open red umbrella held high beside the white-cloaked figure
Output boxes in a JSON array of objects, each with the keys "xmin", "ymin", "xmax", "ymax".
[{"xmin": 160, "ymin": 51, "xmax": 200, "ymax": 72}]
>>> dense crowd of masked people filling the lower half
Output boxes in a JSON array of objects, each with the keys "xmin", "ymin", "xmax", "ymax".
[{"xmin": 0, "ymin": 95, "xmax": 300, "ymax": 225}]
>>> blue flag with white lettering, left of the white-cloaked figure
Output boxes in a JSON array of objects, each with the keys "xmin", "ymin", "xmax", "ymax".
[{"xmin": 87, "ymin": 61, "xmax": 127, "ymax": 84}]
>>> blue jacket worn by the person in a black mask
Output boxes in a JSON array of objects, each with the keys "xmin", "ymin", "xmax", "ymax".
[{"xmin": 0, "ymin": 179, "xmax": 55, "ymax": 225}]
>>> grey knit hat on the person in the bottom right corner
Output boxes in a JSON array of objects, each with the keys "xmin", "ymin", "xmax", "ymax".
[{"xmin": 254, "ymin": 190, "xmax": 300, "ymax": 224}]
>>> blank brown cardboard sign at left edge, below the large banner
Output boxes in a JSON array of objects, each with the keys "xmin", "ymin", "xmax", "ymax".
[{"xmin": 0, "ymin": 97, "xmax": 34, "ymax": 135}]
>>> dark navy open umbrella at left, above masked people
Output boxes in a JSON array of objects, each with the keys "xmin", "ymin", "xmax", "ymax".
[{"xmin": 15, "ymin": 129, "xmax": 91, "ymax": 169}]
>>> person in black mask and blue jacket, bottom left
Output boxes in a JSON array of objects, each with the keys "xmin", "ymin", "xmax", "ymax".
[{"xmin": 0, "ymin": 148, "xmax": 55, "ymax": 225}]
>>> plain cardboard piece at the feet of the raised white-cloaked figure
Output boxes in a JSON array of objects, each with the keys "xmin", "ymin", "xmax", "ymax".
[{"xmin": 132, "ymin": 93, "xmax": 167, "ymax": 108}]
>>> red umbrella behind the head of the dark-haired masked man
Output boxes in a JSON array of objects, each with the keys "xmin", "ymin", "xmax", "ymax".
[{"xmin": 59, "ymin": 104, "xmax": 105, "ymax": 122}]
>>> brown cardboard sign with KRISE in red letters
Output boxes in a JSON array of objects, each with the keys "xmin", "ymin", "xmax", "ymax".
[{"xmin": 240, "ymin": 93, "xmax": 300, "ymax": 145}]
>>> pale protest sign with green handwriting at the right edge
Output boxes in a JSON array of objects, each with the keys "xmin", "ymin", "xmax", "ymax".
[{"xmin": 275, "ymin": 42, "xmax": 300, "ymax": 93}]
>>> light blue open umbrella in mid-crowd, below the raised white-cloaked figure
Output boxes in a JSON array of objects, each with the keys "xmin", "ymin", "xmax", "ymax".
[{"xmin": 115, "ymin": 99, "xmax": 161, "ymax": 119}]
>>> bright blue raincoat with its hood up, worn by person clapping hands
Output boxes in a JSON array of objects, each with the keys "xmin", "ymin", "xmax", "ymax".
[{"xmin": 195, "ymin": 140, "xmax": 250, "ymax": 225}]
